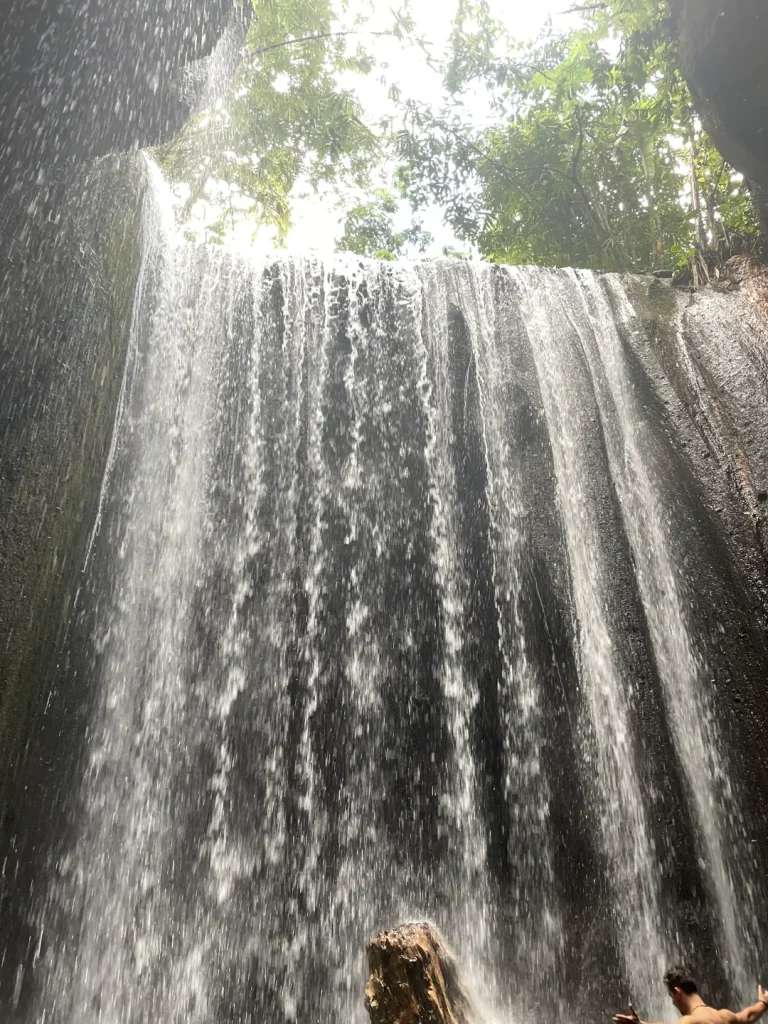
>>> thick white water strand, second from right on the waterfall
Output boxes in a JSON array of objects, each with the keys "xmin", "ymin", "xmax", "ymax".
[{"xmin": 513, "ymin": 271, "xmax": 667, "ymax": 1000}]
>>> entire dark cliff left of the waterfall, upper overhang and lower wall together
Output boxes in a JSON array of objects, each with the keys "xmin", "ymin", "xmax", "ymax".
[{"xmin": 0, "ymin": 0, "xmax": 240, "ymax": 804}]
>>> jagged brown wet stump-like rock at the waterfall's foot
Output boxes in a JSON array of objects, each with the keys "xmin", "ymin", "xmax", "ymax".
[{"xmin": 366, "ymin": 923, "xmax": 477, "ymax": 1024}]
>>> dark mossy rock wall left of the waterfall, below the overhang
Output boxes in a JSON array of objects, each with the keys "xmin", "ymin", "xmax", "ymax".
[{"xmin": 0, "ymin": 158, "xmax": 143, "ymax": 1007}]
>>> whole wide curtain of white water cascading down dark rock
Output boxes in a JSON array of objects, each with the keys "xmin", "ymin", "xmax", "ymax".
[{"xmin": 22, "ymin": 161, "xmax": 760, "ymax": 1024}]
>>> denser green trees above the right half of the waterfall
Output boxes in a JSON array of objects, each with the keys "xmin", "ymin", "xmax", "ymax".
[{"xmin": 398, "ymin": 0, "xmax": 757, "ymax": 270}]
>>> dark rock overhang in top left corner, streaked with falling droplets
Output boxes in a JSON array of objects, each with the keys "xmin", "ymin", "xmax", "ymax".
[{"xmin": 0, "ymin": 0, "xmax": 234, "ymax": 188}]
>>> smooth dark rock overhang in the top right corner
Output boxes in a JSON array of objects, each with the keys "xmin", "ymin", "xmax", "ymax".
[{"xmin": 670, "ymin": 0, "xmax": 768, "ymax": 230}]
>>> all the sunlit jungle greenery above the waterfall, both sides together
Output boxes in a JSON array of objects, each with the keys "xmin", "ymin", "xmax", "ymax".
[{"xmin": 163, "ymin": 0, "xmax": 758, "ymax": 271}]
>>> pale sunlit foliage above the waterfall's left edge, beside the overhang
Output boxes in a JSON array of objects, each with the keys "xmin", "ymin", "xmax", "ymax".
[{"xmin": 160, "ymin": 0, "xmax": 378, "ymax": 238}]
